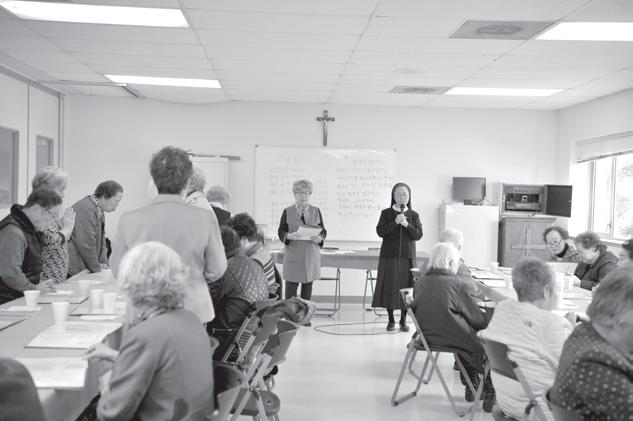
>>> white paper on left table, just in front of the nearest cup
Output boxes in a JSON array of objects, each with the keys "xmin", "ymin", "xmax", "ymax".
[{"xmin": 26, "ymin": 322, "xmax": 121, "ymax": 349}]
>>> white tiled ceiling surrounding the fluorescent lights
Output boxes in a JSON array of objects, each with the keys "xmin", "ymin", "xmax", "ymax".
[{"xmin": 0, "ymin": 0, "xmax": 633, "ymax": 109}]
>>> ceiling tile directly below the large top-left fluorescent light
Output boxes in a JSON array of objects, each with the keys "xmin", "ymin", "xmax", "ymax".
[{"xmin": 26, "ymin": 21, "xmax": 198, "ymax": 44}]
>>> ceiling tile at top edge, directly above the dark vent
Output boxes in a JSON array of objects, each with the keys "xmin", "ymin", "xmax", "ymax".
[{"xmin": 376, "ymin": 0, "xmax": 591, "ymax": 21}]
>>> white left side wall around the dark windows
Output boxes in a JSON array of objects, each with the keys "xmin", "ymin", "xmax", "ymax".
[{"xmin": 0, "ymin": 69, "xmax": 59, "ymax": 218}]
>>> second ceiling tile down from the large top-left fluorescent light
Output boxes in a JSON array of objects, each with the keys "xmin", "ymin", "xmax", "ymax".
[{"xmin": 52, "ymin": 38, "xmax": 206, "ymax": 58}]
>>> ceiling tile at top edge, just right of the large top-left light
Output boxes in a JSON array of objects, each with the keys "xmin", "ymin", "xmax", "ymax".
[{"xmin": 180, "ymin": 0, "xmax": 378, "ymax": 16}]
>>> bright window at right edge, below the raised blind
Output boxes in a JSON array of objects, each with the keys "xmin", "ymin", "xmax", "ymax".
[{"xmin": 590, "ymin": 153, "xmax": 633, "ymax": 239}]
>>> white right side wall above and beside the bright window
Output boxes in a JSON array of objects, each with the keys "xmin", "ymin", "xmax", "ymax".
[{"xmin": 557, "ymin": 89, "xmax": 633, "ymax": 235}]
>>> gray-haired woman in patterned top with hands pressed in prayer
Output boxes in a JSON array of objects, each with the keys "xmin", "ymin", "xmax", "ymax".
[{"xmin": 31, "ymin": 166, "xmax": 75, "ymax": 283}]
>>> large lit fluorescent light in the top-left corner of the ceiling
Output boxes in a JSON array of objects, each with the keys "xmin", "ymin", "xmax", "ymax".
[{"xmin": 0, "ymin": 1, "xmax": 189, "ymax": 28}]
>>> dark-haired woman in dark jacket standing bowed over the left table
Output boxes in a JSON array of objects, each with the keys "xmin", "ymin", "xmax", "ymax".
[{"xmin": 68, "ymin": 180, "xmax": 123, "ymax": 276}]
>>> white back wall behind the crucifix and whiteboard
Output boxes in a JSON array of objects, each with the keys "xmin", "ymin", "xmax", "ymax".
[{"xmin": 66, "ymin": 96, "xmax": 559, "ymax": 295}]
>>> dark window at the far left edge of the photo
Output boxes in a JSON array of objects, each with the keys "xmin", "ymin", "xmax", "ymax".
[{"xmin": 0, "ymin": 127, "xmax": 18, "ymax": 209}]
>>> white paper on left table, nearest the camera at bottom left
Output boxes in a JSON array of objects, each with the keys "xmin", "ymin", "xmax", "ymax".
[{"xmin": 17, "ymin": 357, "xmax": 88, "ymax": 389}]
